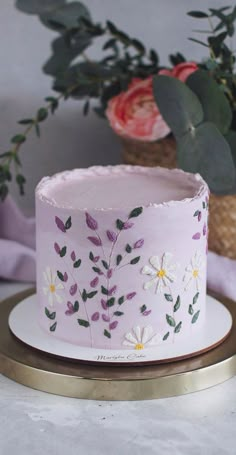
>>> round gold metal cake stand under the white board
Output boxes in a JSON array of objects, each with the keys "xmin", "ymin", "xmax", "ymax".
[{"xmin": 0, "ymin": 289, "xmax": 236, "ymax": 400}]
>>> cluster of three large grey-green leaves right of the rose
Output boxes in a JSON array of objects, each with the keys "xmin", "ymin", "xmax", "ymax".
[{"xmin": 153, "ymin": 70, "xmax": 236, "ymax": 194}]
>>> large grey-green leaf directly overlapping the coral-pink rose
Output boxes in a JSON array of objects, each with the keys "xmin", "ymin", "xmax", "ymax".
[{"xmin": 153, "ymin": 76, "xmax": 204, "ymax": 137}]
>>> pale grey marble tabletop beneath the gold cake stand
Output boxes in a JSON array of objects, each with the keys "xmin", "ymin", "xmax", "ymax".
[{"xmin": 0, "ymin": 282, "xmax": 236, "ymax": 455}]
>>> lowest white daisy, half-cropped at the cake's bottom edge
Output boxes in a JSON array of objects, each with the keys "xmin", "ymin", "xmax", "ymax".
[{"xmin": 123, "ymin": 326, "xmax": 161, "ymax": 350}]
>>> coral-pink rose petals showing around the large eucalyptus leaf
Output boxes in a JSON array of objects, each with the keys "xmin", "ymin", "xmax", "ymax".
[{"xmin": 106, "ymin": 62, "xmax": 198, "ymax": 142}]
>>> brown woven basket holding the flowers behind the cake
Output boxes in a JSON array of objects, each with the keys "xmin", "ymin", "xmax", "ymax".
[{"xmin": 121, "ymin": 136, "xmax": 236, "ymax": 259}]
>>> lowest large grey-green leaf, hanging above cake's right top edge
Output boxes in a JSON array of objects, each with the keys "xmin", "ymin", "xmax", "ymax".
[{"xmin": 177, "ymin": 122, "xmax": 236, "ymax": 194}]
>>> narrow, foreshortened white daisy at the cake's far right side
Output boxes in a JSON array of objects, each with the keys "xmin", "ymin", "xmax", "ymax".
[{"xmin": 184, "ymin": 251, "xmax": 205, "ymax": 290}]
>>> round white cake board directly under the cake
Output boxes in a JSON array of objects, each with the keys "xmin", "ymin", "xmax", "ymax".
[{"xmin": 8, "ymin": 294, "xmax": 232, "ymax": 365}]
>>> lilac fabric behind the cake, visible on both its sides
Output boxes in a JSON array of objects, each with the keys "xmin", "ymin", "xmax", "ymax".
[{"xmin": 0, "ymin": 197, "xmax": 236, "ymax": 300}]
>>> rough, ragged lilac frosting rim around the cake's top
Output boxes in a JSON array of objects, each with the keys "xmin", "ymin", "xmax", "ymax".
[{"xmin": 35, "ymin": 164, "xmax": 209, "ymax": 211}]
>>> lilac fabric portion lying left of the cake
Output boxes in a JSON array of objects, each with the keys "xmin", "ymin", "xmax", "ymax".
[{"xmin": 0, "ymin": 197, "xmax": 36, "ymax": 281}]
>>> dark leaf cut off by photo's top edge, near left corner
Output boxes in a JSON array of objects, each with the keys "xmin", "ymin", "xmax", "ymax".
[{"xmin": 16, "ymin": 0, "xmax": 65, "ymax": 14}]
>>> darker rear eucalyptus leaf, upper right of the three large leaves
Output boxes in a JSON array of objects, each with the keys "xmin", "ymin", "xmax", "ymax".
[{"xmin": 186, "ymin": 70, "xmax": 232, "ymax": 134}]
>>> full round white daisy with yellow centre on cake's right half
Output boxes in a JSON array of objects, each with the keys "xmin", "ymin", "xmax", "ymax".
[{"xmin": 142, "ymin": 253, "xmax": 178, "ymax": 293}]
